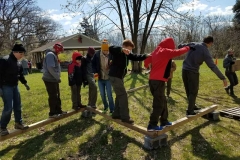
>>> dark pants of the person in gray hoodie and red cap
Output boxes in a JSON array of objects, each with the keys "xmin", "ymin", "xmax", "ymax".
[{"xmin": 44, "ymin": 81, "xmax": 62, "ymax": 116}]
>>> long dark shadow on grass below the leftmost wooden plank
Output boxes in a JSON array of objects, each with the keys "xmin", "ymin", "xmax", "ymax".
[{"xmin": 0, "ymin": 119, "xmax": 94, "ymax": 160}]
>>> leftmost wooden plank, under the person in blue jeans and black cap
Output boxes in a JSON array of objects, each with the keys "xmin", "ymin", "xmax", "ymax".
[{"xmin": 0, "ymin": 108, "xmax": 85, "ymax": 142}]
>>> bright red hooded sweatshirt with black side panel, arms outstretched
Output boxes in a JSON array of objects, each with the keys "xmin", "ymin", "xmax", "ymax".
[{"xmin": 144, "ymin": 38, "xmax": 190, "ymax": 82}]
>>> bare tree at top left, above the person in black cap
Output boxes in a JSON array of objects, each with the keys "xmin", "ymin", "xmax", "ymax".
[{"xmin": 0, "ymin": 0, "xmax": 62, "ymax": 54}]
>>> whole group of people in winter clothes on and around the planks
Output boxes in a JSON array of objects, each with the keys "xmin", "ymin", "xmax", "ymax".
[{"xmin": 0, "ymin": 36, "xmax": 238, "ymax": 135}]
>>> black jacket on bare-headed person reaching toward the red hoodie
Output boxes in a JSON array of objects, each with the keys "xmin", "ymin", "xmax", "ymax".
[{"xmin": 109, "ymin": 46, "xmax": 147, "ymax": 79}]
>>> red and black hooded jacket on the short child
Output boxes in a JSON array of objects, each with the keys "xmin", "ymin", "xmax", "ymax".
[{"xmin": 68, "ymin": 52, "xmax": 86, "ymax": 86}]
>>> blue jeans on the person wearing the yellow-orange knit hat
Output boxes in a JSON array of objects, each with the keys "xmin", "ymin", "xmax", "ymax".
[{"xmin": 98, "ymin": 79, "xmax": 114, "ymax": 112}]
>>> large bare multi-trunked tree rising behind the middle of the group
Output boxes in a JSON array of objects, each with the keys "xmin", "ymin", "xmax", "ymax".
[{"xmin": 65, "ymin": 0, "xmax": 188, "ymax": 72}]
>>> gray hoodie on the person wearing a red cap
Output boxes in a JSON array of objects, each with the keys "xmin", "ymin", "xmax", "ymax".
[{"xmin": 42, "ymin": 50, "xmax": 61, "ymax": 82}]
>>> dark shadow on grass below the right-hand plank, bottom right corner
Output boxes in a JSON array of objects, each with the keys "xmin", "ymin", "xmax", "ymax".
[{"xmin": 166, "ymin": 121, "xmax": 240, "ymax": 160}]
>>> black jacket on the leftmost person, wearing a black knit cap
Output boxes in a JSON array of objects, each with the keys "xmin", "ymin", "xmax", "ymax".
[{"xmin": 0, "ymin": 53, "xmax": 27, "ymax": 87}]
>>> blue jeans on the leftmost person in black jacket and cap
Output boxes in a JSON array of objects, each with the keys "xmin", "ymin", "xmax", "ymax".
[{"xmin": 0, "ymin": 85, "xmax": 22, "ymax": 129}]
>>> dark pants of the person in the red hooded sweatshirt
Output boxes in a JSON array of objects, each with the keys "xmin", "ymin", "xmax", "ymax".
[{"xmin": 149, "ymin": 80, "xmax": 168, "ymax": 126}]
